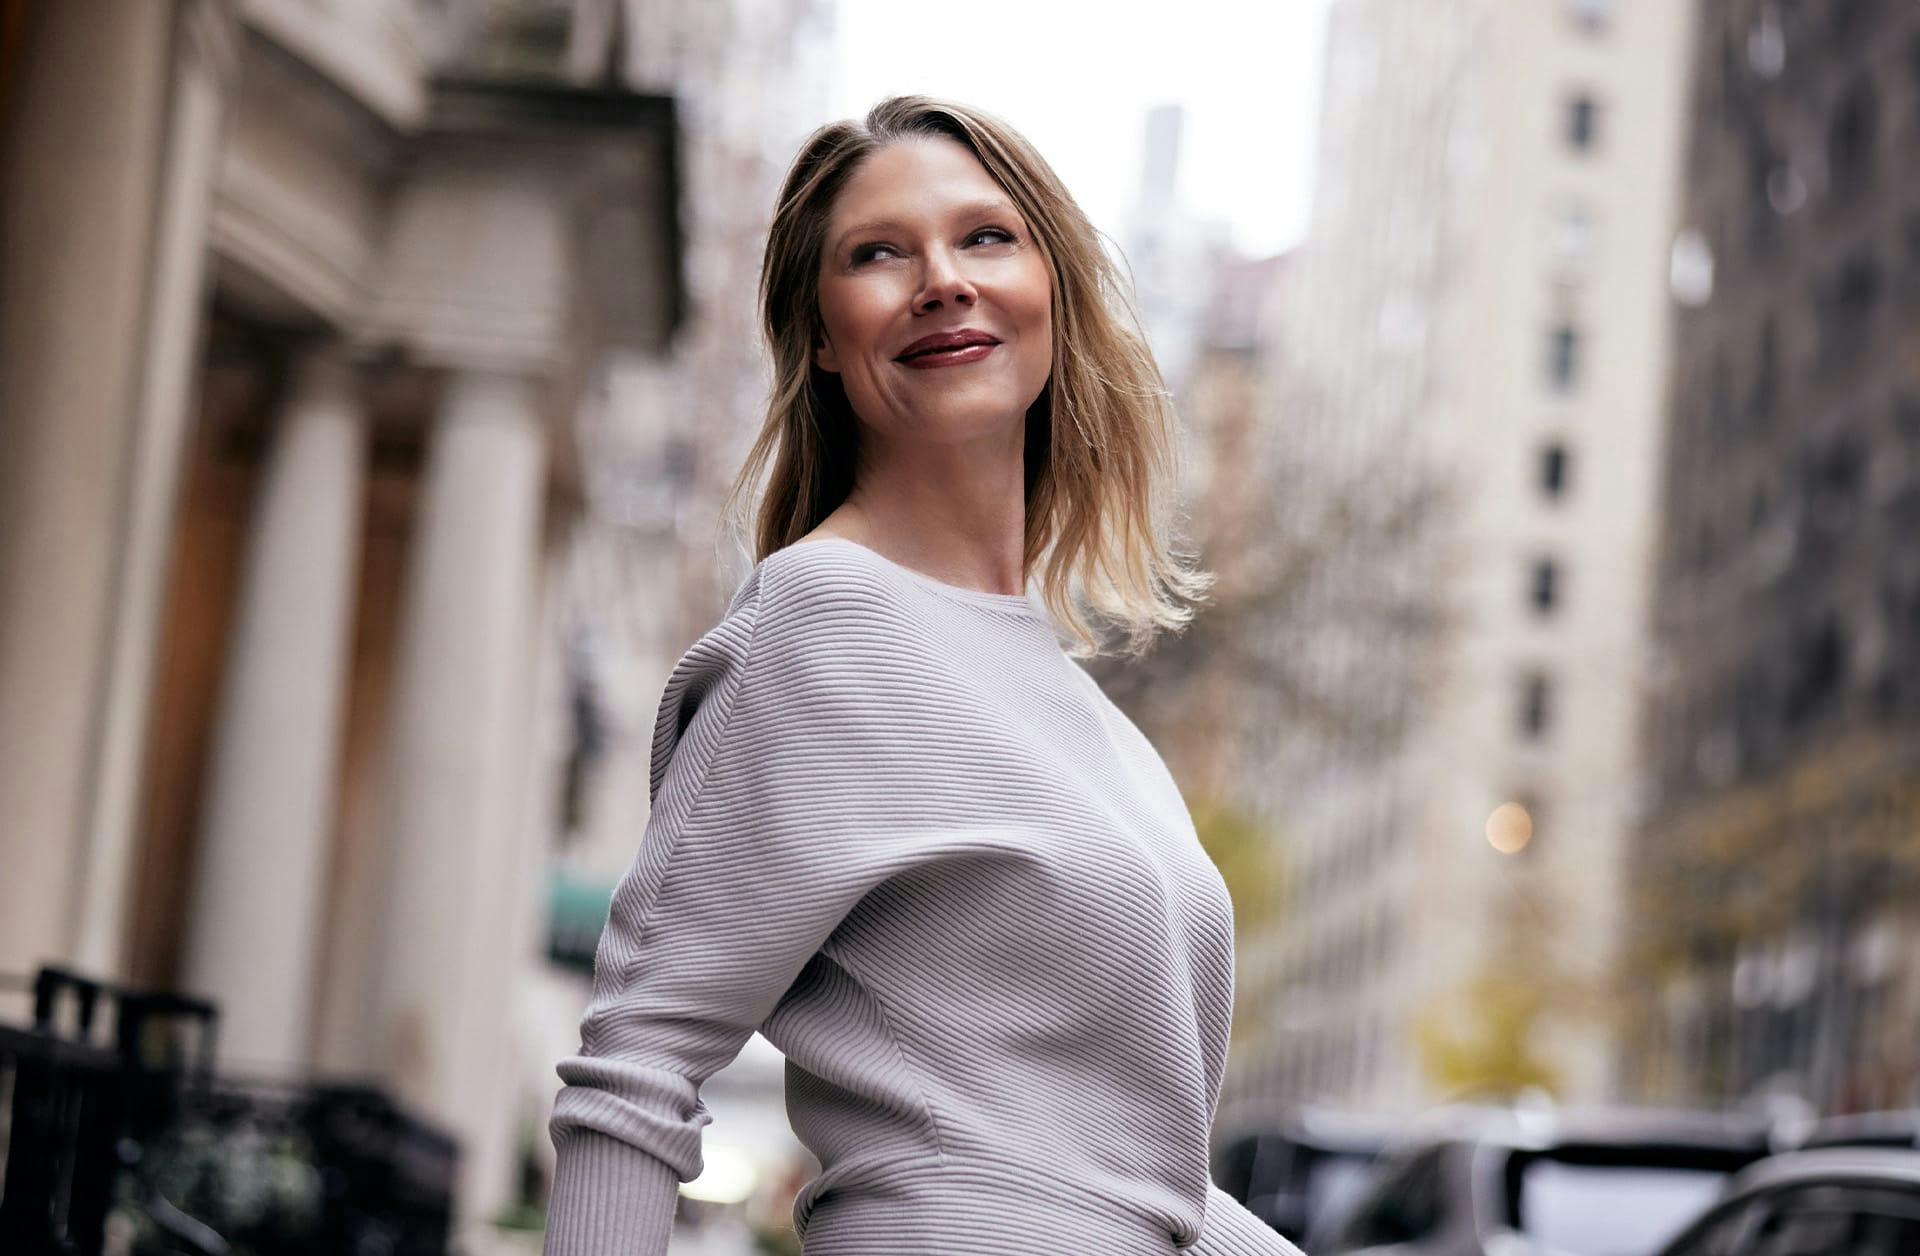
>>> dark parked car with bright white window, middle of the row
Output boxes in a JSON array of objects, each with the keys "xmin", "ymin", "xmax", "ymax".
[{"xmin": 1306, "ymin": 1112, "xmax": 1768, "ymax": 1256}]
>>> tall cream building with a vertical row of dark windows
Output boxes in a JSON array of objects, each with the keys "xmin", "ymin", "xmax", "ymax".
[{"xmin": 1229, "ymin": 0, "xmax": 1690, "ymax": 1110}]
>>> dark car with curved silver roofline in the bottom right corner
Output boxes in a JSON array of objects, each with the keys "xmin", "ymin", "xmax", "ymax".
[{"xmin": 1661, "ymin": 1147, "xmax": 1920, "ymax": 1256}]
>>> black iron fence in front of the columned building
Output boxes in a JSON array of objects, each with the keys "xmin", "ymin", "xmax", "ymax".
[{"xmin": 0, "ymin": 970, "xmax": 459, "ymax": 1256}]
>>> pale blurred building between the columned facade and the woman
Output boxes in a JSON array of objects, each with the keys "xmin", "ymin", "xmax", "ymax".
[{"xmin": 522, "ymin": 0, "xmax": 833, "ymax": 1243}]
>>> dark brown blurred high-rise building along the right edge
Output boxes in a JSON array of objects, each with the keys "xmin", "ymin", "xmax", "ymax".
[{"xmin": 1626, "ymin": 0, "xmax": 1920, "ymax": 1110}]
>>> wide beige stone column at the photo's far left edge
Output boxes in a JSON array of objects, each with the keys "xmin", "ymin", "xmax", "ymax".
[{"xmin": 0, "ymin": 0, "xmax": 175, "ymax": 970}]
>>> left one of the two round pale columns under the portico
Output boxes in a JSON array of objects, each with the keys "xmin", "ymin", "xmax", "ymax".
[{"xmin": 182, "ymin": 350, "xmax": 367, "ymax": 1072}]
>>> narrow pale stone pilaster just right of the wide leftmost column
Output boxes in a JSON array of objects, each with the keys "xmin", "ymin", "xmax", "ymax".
[{"xmin": 73, "ymin": 0, "xmax": 238, "ymax": 974}]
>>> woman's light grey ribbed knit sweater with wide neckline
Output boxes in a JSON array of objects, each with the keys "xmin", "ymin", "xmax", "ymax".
[{"xmin": 545, "ymin": 538, "xmax": 1296, "ymax": 1256}]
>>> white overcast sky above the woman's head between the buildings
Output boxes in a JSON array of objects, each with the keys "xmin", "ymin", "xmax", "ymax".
[{"xmin": 833, "ymin": 0, "xmax": 1327, "ymax": 255}]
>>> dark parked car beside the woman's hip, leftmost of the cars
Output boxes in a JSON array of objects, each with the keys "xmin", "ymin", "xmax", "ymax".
[{"xmin": 1213, "ymin": 1110, "xmax": 1398, "ymax": 1243}]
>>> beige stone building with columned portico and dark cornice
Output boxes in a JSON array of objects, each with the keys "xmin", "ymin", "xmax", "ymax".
[{"xmin": 0, "ymin": 0, "xmax": 685, "ymax": 1218}]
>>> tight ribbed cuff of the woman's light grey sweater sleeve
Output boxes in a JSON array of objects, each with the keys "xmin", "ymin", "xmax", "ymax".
[{"xmin": 545, "ymin": 1129, "xmax": 680, "ymax": 1256}]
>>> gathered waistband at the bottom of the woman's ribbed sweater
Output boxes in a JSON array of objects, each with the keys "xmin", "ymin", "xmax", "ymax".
[{"xmin": 793, "ymin": 1154, "xmax": 1198, "ymax": 1256}]
